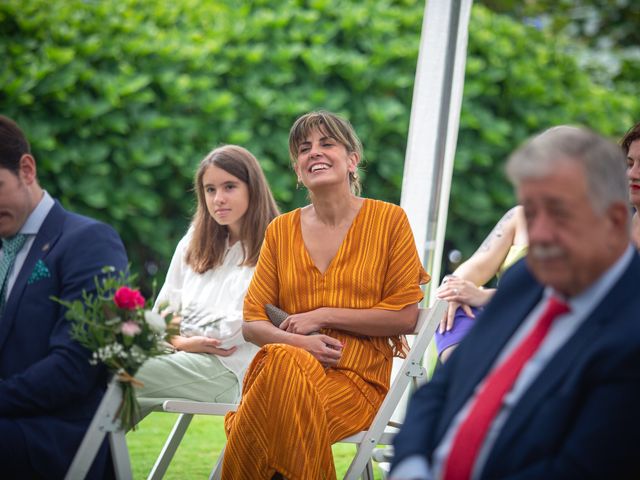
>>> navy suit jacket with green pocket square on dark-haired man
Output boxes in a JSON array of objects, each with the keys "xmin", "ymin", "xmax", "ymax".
[{"xmin": 0, "ymin": 202, "xmax": 127, "ymax": 478}]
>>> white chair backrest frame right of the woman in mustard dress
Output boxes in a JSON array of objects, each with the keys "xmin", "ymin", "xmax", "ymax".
[{"xmin": 342, "ymin": 300, "xmax": 448, "ymax": 480}]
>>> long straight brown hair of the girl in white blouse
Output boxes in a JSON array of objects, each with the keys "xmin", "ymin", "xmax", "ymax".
[{"xmin": 185, "ymin": 145, "xmax": 279, "ymax": 273}]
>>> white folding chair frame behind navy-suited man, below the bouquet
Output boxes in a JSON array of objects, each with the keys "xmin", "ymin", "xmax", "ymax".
[{"xmin": 64, "ymin": 377, "xmax": 132, "ymax": 480}]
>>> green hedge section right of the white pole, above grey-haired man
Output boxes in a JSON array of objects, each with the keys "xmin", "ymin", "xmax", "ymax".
[{"xmin": 447, "ymin": 6, "xmax": 640, "ymax": 256}]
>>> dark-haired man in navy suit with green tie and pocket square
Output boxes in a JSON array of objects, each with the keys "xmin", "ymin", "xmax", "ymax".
[{"xmin": 0, "ymin": 116, "xmax": 127, "ymax": 479}]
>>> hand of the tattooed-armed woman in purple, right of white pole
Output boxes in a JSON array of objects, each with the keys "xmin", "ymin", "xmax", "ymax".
[{"xmin": 436, "ymin": 276, "xmax": 495, "ymax": 333}]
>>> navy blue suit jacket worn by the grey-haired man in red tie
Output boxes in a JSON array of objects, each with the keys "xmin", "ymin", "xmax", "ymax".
[{"xmin": 394, "ymin": 253, "xmax": 640, "ymax": 480}]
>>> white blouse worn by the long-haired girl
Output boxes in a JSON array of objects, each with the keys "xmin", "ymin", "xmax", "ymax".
[{"xmin": 154, "ymin": 228, "xmax": 258, "ymax": 384}]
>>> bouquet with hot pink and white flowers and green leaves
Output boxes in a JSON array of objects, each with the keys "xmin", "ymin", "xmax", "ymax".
[{"xmin": 54, "ymin": 267, "xmax": 174, "ymax": 431}]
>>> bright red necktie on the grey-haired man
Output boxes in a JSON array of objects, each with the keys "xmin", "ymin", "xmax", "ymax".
[{"xmin": 444, "ymin": 297, "xmax": 569, "ymax": 480}]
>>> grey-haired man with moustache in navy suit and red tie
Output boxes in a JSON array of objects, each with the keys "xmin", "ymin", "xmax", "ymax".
[{"xmin": 391, "ymin": 127, "xmax": 640, "ymax": 480}]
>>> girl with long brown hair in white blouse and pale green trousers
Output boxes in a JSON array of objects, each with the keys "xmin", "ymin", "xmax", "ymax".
[{"xmin": 136, "ymin": 145, "xmax": 278, "ymax": 418}]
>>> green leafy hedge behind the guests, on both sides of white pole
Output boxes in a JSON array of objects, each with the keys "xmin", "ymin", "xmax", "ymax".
[{"xmin": 0, "ymin": 0, "xmax": 638, "ymax": 282}]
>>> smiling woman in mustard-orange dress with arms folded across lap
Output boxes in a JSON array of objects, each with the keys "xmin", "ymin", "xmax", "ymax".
[{"xmin": 222, "ymin": 112, "xmax": 429, "ymax": 480}]
